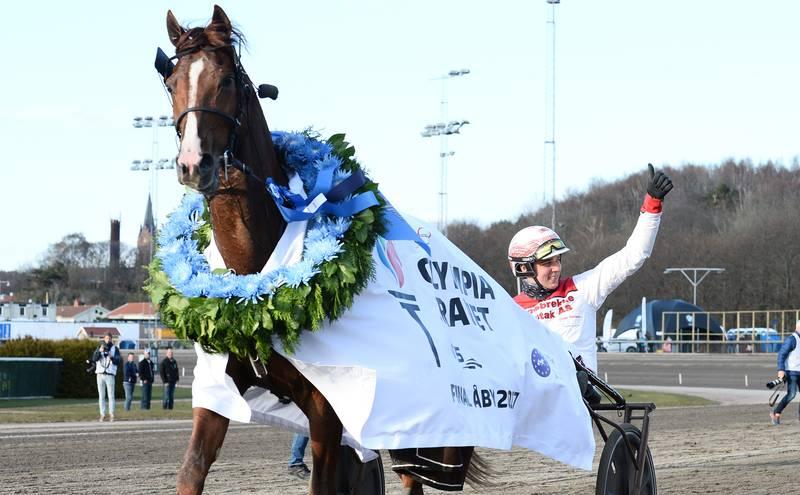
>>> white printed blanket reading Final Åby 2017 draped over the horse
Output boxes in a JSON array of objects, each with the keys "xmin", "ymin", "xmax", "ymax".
[{"xmin": 192, "ymin": 218, "xmax": 594, "ymax": 469}]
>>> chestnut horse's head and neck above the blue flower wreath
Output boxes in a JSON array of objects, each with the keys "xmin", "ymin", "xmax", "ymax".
[{"xmin": 162, "ymin": 6, "xmax": 288, "ymax": 273}]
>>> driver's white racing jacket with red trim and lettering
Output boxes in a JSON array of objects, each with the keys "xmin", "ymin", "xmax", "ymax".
[{"xmin": 514, "ymin": 195, "xmax": 661, "ymax": 371}]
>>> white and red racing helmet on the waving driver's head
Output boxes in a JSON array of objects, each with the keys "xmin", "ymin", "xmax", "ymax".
[{"xmin": 508, "ymin": 225, "xmax": 569, "ymax": 278}]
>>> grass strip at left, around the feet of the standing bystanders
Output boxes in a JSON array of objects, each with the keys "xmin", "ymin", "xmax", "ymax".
[{"xmin": 0, "ymin": 386, "xmax": 192, "ymax": 423}]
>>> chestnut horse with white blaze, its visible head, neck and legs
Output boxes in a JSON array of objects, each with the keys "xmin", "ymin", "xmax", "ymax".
[{"xmin": 162, "ymin": 6, "xmax": 486, "ymax": 495}]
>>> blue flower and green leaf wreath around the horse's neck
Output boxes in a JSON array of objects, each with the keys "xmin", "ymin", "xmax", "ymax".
[{"xmin": 151, "ymin": 132, "xmax": 386, "ymax": 360}]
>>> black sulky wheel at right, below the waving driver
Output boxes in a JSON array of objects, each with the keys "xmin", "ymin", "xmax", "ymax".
[{"xmin": 595, "ymin": 423, "xmax": 658, "ymax": 495}]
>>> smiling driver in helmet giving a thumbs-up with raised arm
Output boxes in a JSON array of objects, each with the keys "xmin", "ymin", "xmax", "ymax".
[{"xmin": 508, "ymin": 164, "xmax": 672, "ymax": 371}]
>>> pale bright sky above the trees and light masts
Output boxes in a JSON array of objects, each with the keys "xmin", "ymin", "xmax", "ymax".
[{"xmin": 0, "ymin": 0, "xmax": 800, "ymax": 270}]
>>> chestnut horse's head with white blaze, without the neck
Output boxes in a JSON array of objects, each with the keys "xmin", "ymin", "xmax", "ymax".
[{"xmin": 165, "ymin": 6, "xmax": 254, "ymax": 196}]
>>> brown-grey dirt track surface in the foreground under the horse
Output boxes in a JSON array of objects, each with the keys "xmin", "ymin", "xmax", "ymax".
[{"xmin": 0, "ymin": 404, "xmax": 800, "ymax": 495}]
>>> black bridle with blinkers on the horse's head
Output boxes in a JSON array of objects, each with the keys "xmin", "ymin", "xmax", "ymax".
[{"xmin": 155, "ymin": 45, "xmax": 278, "ymax": 184}]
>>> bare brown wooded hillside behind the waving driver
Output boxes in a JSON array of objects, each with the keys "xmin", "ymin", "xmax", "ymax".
[{"xmin": 448, "ymin": 161, "xmax": 800, "ymax": 330}]
